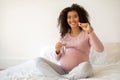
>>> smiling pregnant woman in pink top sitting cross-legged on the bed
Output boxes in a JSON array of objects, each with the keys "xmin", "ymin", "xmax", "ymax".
[{"xmin": 37, "ymin": 4, "xmax": 104, "ymax": 80}]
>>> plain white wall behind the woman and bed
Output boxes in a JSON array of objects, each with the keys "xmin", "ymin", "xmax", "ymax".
[{"xmin": 0, "ymin": 0, "xmax": 120, "ymax": 68}]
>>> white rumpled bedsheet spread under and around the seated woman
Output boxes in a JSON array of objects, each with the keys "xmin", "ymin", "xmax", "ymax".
[{"xmin": 0, "ymin": 59, "xmax": 120, "ymax": 80}]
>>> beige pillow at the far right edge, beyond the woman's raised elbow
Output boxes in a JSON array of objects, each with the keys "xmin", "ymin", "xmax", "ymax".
[{"xmin": 104, "ymin": 42, "xmax": 120, "ymax": 64}]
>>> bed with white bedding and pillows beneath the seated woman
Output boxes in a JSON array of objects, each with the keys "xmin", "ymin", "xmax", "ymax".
[{"xmin": 0, "ymin": 42, "xmax": 120, "ymax": 80}]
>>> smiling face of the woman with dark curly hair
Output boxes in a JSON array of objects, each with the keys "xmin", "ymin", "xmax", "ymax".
[{"xmin": 67, "ymin": 11, "xmax": 79, "ymax": 28}]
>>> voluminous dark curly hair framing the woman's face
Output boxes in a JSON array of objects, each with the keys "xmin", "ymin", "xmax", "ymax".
[{"xmin": 58, "ymin": 4, "xmax": 90, "ymax": 37}]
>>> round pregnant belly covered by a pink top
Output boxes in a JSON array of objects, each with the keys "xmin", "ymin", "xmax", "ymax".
[{"xmin": 60, "ymin": 49, "xmax": 87, "ymax": 71}]
